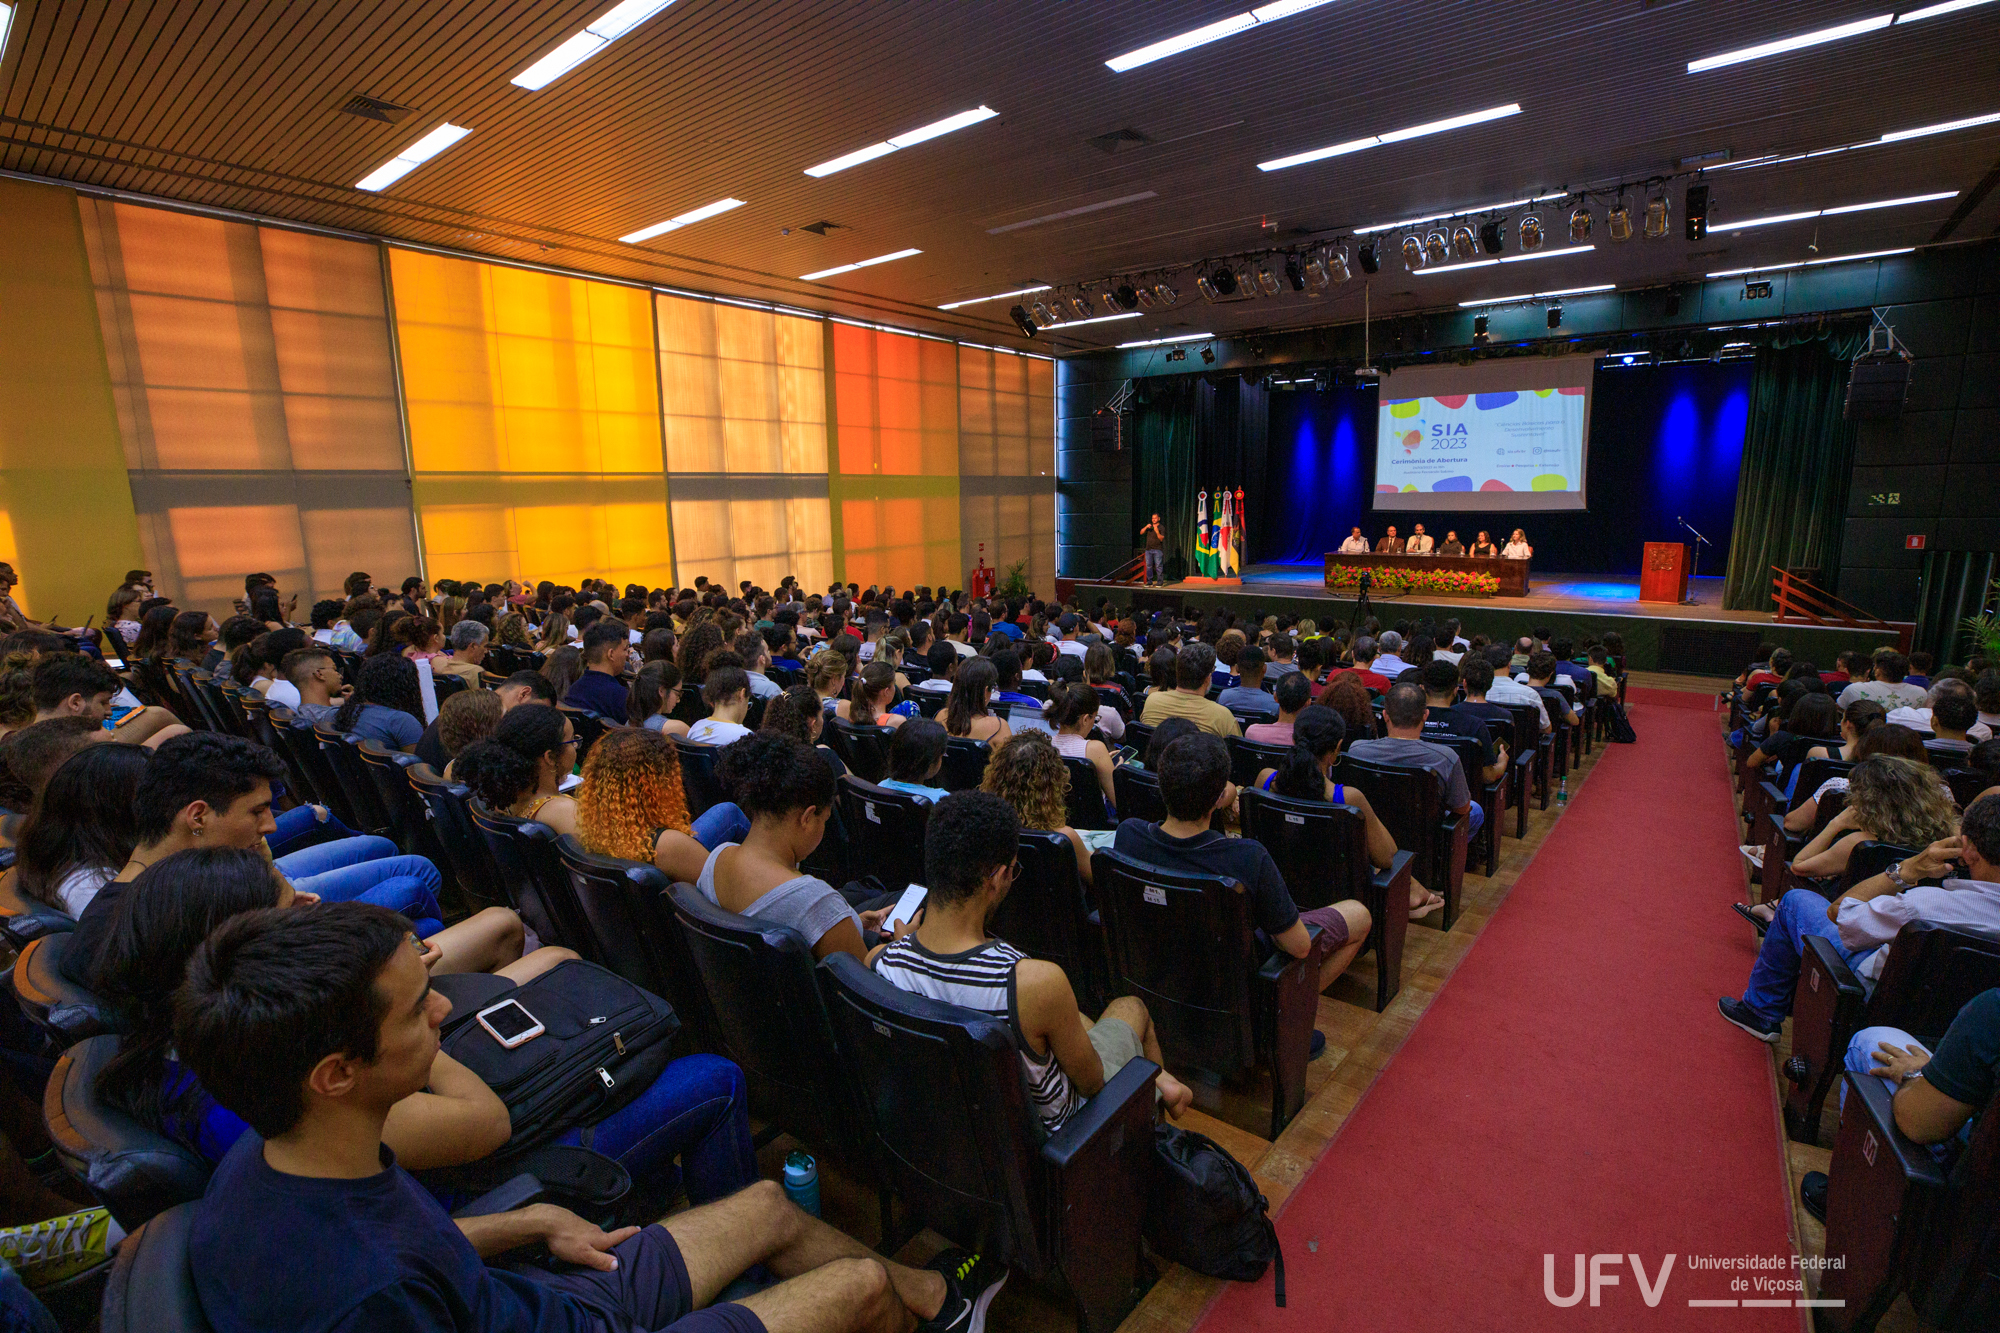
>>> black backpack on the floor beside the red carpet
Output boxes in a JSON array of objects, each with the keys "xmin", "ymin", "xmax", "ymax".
[{"xmin": 1146, "ymin": 1121, "xmax": 1284, "ymax": 1309}]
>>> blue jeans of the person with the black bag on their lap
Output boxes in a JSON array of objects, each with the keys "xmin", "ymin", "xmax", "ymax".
[{"xmin": 556, "ymin": 1055, "xmax": 756, "ymax": 1203}]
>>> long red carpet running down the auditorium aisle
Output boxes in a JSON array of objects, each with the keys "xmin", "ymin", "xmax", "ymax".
[{"xmin": 1200, "ymin": 691, "xmax": 1808, "ymax": 1333}]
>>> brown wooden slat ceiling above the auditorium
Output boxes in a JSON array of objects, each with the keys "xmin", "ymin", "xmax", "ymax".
[{"xmin": 0, "ymin": 0, "xmax": 2000, "ymax": 348}]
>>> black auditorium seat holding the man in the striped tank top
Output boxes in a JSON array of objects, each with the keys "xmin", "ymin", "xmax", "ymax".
[{"xmin": 820, "ymin": 953, "xmax": 1160, "ymax": 1333}]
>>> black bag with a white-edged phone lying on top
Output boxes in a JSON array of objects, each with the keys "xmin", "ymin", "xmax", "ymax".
[{"xmin": 442, "ymin": 959, "xmax": 680, "ymax": 1161}]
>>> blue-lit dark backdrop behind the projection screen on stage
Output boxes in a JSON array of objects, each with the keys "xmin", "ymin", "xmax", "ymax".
[{"xmin": 1250, "ymin": 360, "xmax": 1750, "ymax": 574}]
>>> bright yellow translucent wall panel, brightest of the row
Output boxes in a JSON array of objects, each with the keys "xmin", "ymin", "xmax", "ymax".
[{"xmin": 390, "ymin": 248, "xmax": 672, "ymax": 586}]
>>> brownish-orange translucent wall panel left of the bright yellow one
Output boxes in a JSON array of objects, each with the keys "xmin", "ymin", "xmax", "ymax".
[{"xmin": 78, "ymin": 198, "xmax": 416, "ymax": 612}]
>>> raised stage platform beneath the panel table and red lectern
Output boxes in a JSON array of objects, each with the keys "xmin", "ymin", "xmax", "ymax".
[{"xmin": 1060, "ymin": 562, "xmax": 1896, "ymax": 677}]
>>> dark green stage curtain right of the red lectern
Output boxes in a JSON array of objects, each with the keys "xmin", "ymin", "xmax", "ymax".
[{"xmin": 1722, "ymin": 340, "xmax": 1854, "ymax": 610}]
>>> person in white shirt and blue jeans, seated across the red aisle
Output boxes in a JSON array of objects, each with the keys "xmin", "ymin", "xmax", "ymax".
[{"xmin": 1716, "ymin": 793, "xmax": 2000, "ymax": 1045}]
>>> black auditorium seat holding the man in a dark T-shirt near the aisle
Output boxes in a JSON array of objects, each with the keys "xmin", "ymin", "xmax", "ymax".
[{"xmin": 1090, "ymin": 851, "xmax": 1330, "ymax": 1139}]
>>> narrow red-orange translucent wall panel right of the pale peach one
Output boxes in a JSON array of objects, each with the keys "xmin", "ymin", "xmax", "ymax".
[{"xmin": 828, "ymin": 322, "xmax": 966, "ymax": 588}]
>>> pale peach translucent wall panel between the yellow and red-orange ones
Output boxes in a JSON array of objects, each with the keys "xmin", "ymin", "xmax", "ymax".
[{"xmin": 654, "ymin": 294, "xmax": 834, "ymax": 588}]
